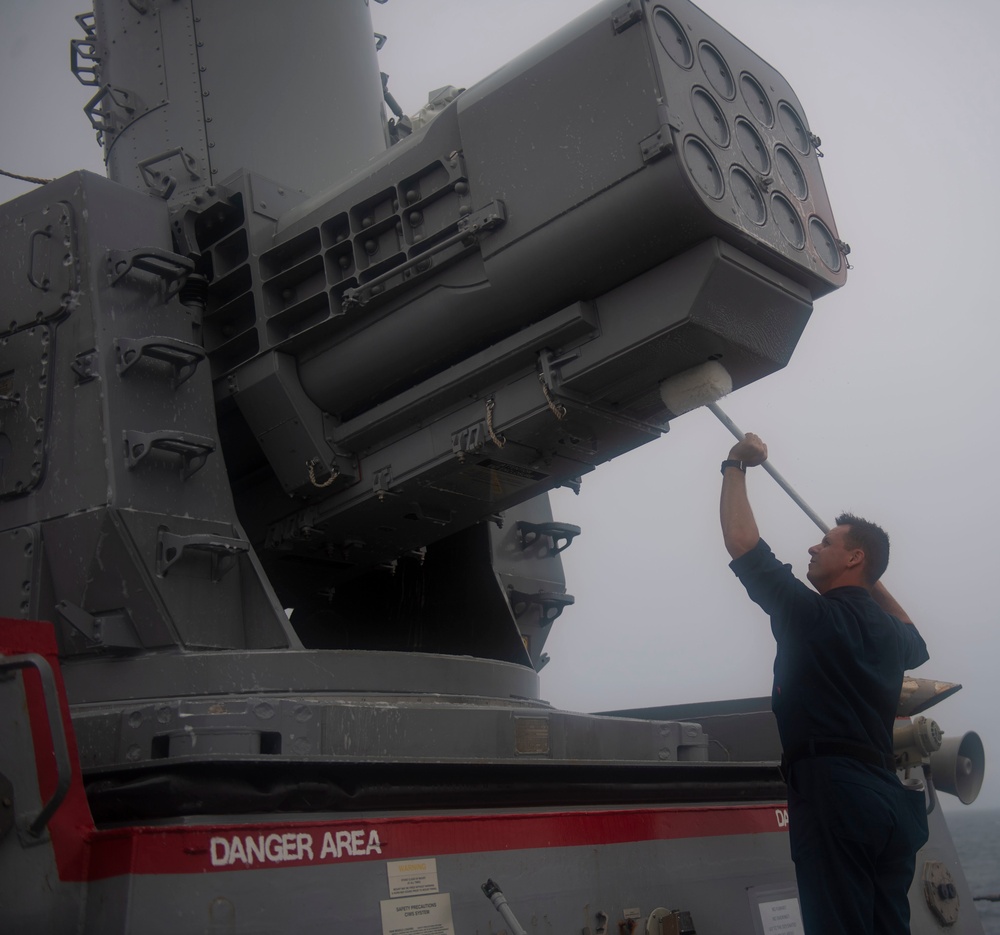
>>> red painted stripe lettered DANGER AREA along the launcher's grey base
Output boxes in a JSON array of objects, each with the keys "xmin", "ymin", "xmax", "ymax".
[{"xmin": 0, "ymin": 621, "xmax": 787, "ymax": 881}]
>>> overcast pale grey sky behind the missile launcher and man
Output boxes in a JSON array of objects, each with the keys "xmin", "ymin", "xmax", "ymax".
[{"xmin": 0, "ymin": 0, "xmax": 1000, "ymax": 807}]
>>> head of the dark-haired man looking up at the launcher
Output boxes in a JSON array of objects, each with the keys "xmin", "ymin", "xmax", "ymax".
[{"xmin": 806, "ymin": 513, "xmax": 889, "ymax": 594}]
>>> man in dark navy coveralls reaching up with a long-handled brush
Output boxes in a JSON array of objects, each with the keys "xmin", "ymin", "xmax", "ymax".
[{"xmin": 720, "ymin": 434, "xmax": 928, "ymax": 935}]
